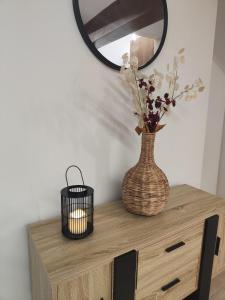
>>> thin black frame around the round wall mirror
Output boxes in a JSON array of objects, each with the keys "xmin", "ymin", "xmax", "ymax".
[{"xmin": 73, "ymin": 0, "xmax": 168, "ymax": 71}]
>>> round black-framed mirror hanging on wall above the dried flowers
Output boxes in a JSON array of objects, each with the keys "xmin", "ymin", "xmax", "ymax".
[{"xmin": 73, "ymin": 0, "xmax": 168, "ymax": 70}]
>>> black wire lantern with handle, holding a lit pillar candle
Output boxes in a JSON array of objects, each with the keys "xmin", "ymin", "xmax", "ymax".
[{"xmin": 61, "ymin": 165, "xmax": 94, "ymax": 240}]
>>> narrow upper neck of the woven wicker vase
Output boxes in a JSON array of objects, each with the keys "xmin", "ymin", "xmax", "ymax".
[{"xmin": 139, "ymin": 133, "xmax": 155, "ymax": 164}]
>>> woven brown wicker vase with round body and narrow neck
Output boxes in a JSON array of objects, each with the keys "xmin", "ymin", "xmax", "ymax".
[{"xmin": 122, "ymin": 133, "xmax": 169, "ymax": 216}]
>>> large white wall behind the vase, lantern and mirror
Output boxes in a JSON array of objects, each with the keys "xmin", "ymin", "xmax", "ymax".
[{"xmin": 0, "ymin": 0, "xmax": 217, "ymax": 300}]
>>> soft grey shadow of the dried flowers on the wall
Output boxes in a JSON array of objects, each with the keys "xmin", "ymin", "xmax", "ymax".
[{"xmin": 76, "ymin": 77, "xmax": 135, "ymax": 149}]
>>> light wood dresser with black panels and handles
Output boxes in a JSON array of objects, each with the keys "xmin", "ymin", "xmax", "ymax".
[{"xmin": 28, "ymin": 185, "xmax": 225, "ymax": 300}]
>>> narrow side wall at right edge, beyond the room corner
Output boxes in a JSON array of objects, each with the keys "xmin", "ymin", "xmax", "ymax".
[{"xmin": 202, "ymin": 0, "xmax": 225, "ymax": 197}]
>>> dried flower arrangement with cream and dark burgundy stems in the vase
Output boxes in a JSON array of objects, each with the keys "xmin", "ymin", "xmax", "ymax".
[{"xmin": 120, "ymin": 48, "xmax": 204, "ymax": 134}]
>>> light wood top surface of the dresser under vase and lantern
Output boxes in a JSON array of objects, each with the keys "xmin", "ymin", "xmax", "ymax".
[{"xmin": 28, "ymin": 185, "xmax": 225, "ymax": 283}]
